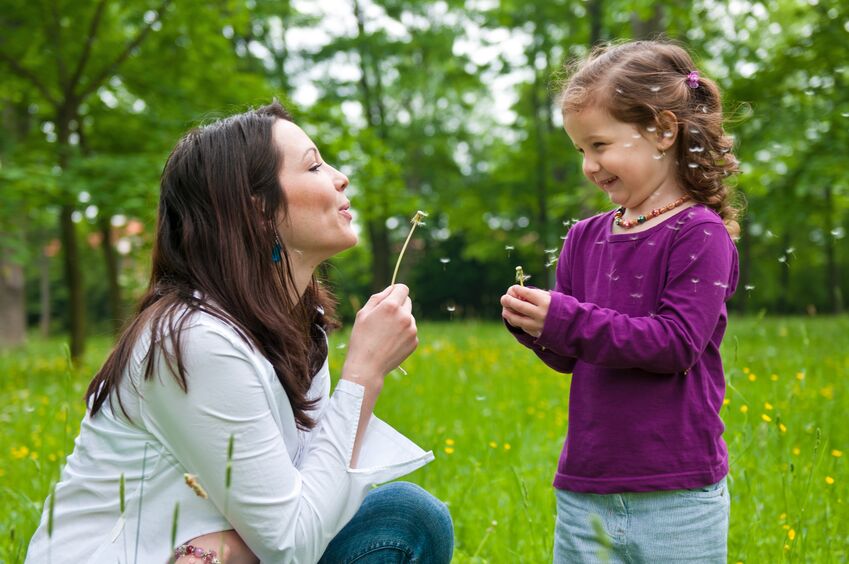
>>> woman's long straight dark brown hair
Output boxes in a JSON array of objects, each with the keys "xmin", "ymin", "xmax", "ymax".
[{"xmin": 86, "ymin": 101, "xmax": 338, "ymax": 428}]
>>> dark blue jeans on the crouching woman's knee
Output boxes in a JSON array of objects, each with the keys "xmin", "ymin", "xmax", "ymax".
[{"xmin": 319, "ymin": 482, "xmax": 454, "ymax": 564}]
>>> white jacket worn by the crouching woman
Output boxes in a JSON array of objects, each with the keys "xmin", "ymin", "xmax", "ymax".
[{"xmin": 26, "ymin": 313, "xmax": 433, "ymax": 564}]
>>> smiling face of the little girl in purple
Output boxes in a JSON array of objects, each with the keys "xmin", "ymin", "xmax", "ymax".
[{"xmin": 563, "ymin": 106, "xmax": 683, "ymax": 213}]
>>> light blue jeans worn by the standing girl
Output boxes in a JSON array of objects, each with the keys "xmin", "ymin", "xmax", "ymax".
[{"xmin": 554, "ymin": 478, "xmax": 731, "ymax": 564}]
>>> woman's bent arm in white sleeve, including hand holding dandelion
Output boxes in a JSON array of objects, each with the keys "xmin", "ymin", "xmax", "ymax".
[{"xmin": 142, "ymin": 285, "xmax": 416, "ymax": 562}]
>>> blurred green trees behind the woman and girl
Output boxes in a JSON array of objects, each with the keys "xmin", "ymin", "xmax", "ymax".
[{"xmin": 0, "ymin": 0, "xmax": 849, "ymax": 357}]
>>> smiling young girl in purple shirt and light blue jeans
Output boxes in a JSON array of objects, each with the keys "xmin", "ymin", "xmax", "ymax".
[{"xmin": 501, "ymin": 41, "xmax": 739, "ymax": 563}]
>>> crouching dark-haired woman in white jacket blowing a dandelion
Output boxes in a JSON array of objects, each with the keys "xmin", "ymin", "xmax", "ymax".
[{"xmin": 27, "ymin": 102, "xmax": 453, "ymax": 564}]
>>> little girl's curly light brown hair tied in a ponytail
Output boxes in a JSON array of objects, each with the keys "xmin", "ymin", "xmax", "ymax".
[{"xmin": 560, "ymin": 41, "xmax": 740, "ymax": 237}]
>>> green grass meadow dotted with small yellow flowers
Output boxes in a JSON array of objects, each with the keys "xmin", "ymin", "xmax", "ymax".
[{"xmin": 0, "ymin": 317, "xmax": 849, "ymax": 563}]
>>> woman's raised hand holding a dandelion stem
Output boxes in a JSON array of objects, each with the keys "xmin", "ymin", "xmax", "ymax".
[{"xmin": 342, "ymin": 284, "xmax": 419, "ymax": 390}]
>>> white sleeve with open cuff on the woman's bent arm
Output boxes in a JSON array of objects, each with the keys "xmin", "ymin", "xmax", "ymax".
[{"xmin": 142, "ymin": 325, "xmax": 433, "ymax": 562}]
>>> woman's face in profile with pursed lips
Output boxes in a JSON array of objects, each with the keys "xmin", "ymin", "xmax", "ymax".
[{"xmin": 272, "ymin": 119, "xmax": 357, "ymax": 266}]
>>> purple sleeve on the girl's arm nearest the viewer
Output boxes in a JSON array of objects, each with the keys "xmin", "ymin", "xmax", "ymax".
[{"xmin": 536, "ymin": 223, "xmax": 737, "ymax": 374}]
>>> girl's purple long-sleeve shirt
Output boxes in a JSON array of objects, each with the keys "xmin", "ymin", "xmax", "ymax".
[{"xmin": 512, "ymin": 205, "xmax": 738, "ymax": 493}]
